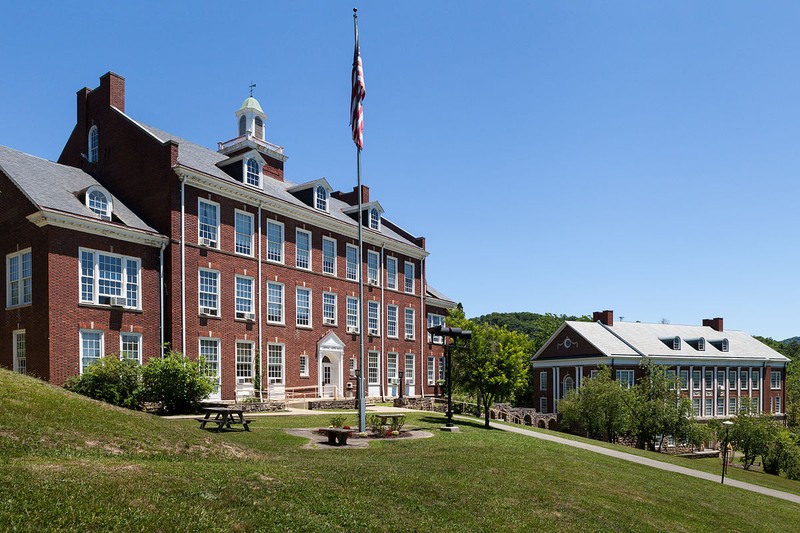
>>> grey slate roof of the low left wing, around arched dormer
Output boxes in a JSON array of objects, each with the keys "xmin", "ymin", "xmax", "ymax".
[{"xmin": 0, "ymin": 146, "xmax": 157, "ymax": 233}]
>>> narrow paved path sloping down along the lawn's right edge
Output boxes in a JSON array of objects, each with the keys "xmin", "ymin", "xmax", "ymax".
[{"xmin": 466, "ymin": 416, "xmax": 800, "ymax": 503}]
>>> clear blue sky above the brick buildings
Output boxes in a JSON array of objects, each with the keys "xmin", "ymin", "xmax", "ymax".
[{"xmin": 0, "ymin": 0, "xmax": 800, "ymax": 339}]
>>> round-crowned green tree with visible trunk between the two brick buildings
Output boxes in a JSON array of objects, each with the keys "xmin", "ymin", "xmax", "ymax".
[{"xmin": 447, "ymin": 309, "xmax": 531, "ymax": 427}]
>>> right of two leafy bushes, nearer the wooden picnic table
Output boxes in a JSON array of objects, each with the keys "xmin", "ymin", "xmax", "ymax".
[{"xmin": 140, "ymin": 352, "xmax": 214, "ymax": 414}]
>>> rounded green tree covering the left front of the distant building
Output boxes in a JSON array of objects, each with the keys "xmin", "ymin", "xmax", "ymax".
[{"xmin": 558, "ymin": 366, "xmax": 630, "ymax": 442}]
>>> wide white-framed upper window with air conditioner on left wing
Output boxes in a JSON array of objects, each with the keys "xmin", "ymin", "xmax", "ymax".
[{"xmin": 79, "ymin": 248, "xmax": 141, "ymax": 309}]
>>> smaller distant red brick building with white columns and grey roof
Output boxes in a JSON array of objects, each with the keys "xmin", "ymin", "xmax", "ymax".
[{"xmin": 531, "ymin": 311, "xmax": 789, "ymax": 419}]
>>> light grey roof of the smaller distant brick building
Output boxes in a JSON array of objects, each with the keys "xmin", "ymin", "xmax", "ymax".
[{"xmin": 537, "ymin": 321, "xmax": 789, "ymax": 362}]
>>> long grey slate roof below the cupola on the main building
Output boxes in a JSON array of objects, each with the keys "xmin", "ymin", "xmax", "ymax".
[{"xmin": 122, "ymin": 109, "xmax": 417, "ymax": 246}]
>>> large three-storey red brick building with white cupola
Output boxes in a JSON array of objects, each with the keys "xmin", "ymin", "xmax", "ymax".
[{"xmin": 0, "ymin": 73, "xmax": 453, "ymax": 400}]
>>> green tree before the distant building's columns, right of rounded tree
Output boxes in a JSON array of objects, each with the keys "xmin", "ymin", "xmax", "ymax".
[{"xmin": 625, "ymin": 359, "xmax": 691, "ymax": 450}]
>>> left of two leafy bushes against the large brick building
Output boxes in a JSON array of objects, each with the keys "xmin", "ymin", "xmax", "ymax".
[{"xmin": 65, "ymin": 355, "xmax": 141, "ymax": 409}]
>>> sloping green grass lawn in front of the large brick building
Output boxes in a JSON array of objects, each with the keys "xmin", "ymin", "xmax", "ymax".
[{"xmin": 0, "ymin": 371, "xmax": 799, "ymax": 532}]
